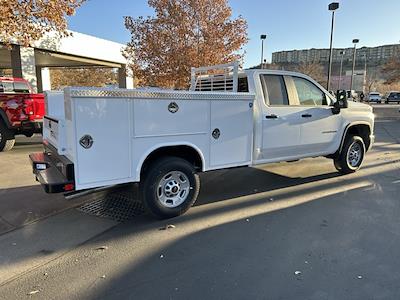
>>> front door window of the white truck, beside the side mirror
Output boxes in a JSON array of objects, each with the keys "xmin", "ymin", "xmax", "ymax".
[{"xmin": 293, "ymin": 77, "xmax": 327, "ymax": 106}]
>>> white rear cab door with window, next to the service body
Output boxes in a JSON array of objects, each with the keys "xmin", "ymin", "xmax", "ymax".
[{"xmin": 260, "ymin": 74, "xmax": 301, "ymax": 161}]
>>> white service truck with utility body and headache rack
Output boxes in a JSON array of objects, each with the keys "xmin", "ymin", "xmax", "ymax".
[{"xmin": 30, "ymin": 63, "xmax": 374, "ymax": 218}]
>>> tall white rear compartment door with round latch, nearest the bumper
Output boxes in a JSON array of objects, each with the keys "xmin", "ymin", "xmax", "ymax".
[{"xmin": 73, "ymin": 98, "xmax": 131, "ymax": 189}]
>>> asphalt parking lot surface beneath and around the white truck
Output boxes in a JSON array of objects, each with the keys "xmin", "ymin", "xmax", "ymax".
[{"xmin": 0, "ymin": 105, "xmax": 400, "ymax": 299}]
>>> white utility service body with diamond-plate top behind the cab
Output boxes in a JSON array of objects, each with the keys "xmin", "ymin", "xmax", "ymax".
[{"xmin": 44, "ymin": 88, "xmax": 254, "ymax": 190}]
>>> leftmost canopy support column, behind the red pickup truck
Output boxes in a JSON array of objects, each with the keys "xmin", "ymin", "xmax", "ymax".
[{"xmin": 11, "ymin": 45, "xmax": 37, "ymax": 92}]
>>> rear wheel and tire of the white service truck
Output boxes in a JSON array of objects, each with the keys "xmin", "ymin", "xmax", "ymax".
[{"xmin": 140, "ymin": 156, "xmax": 200, "ymax": 219}]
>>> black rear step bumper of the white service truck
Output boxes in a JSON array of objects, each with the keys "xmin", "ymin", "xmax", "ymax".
[{"xmin": 29, "ymin": 151, "xmax": 75, "ymax": 193}]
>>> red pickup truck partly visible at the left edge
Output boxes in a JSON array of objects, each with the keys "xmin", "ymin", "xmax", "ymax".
[{"xmin": 0, "ymin": 77, "xmax": 45, "ymax": 152}]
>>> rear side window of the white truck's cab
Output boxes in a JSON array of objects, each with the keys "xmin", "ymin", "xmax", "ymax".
[{"xmin": 260, "ymin": 75, "xmax": 289, "ymax": 106}]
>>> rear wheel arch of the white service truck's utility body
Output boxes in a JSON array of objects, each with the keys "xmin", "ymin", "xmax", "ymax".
[{"xmin": 136, "ymin": 143, "xmax": 205, "ymax": 180}]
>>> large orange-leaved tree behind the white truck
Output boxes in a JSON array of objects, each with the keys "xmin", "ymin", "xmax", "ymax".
[{"xmin": 123, "ymin": 0, "xmax": 248, "ymax": 89}]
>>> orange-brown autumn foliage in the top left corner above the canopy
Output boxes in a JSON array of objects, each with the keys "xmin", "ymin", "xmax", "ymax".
[{"xmin": 0, "ymin": 0, "xmax": 85, "ymax": 46}]
